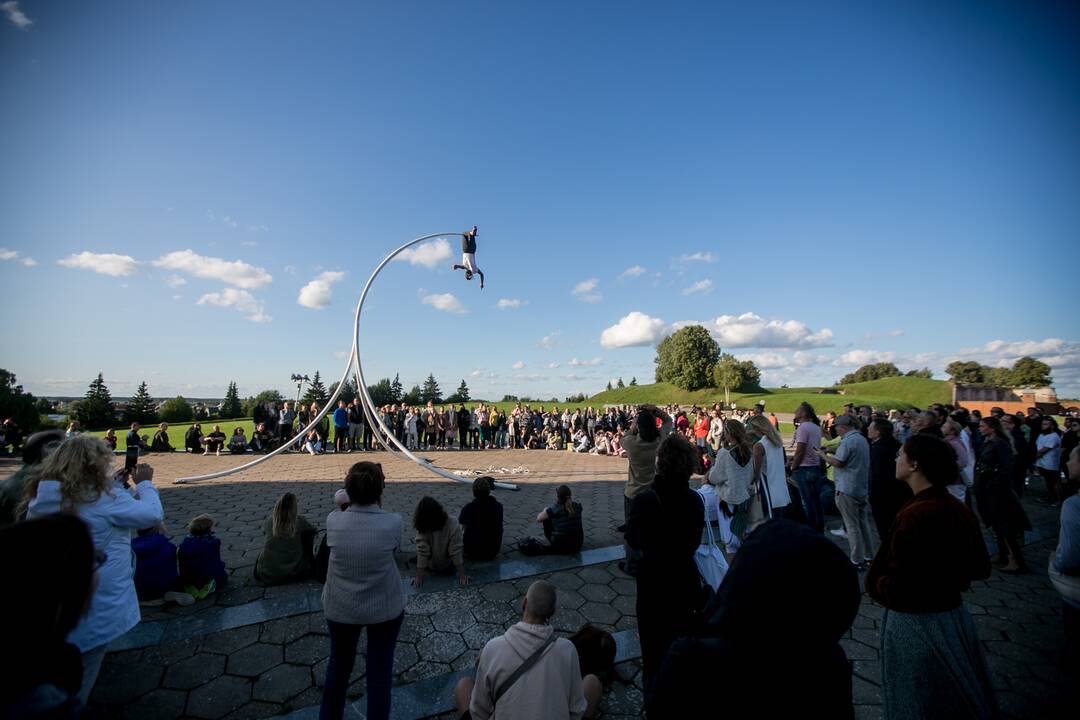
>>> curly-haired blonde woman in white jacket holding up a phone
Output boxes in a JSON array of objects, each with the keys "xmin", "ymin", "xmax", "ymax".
[{"xmin": 26, "ymin": 435, "xmax": 164, "ymax": 705}]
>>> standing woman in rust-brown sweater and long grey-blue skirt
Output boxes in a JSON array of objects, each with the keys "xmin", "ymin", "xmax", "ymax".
[{"xmin": 866, "ymin": 434, "xmax": 997, "ymax": 719}]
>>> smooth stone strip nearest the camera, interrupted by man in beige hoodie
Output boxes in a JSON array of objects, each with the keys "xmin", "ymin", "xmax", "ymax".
[{"xmin": 276, "ymin": 628, "xmax": 642, "ymax": 720}]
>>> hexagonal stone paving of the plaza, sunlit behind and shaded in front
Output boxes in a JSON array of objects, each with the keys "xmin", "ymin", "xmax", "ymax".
[{"xmin": 0, "ymin": 451, "xmax": 1077, "ymax": 719}]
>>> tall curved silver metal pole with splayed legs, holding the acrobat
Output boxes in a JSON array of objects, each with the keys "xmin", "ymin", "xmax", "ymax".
[{"xmin": 174, "ymin": 232, "xmax": 517, "ymax": 490}]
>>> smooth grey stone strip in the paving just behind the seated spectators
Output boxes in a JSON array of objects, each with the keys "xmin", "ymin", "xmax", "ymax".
[{"xmin": 109, "ymin": 545, "xmax": 624, "ymax": 652}]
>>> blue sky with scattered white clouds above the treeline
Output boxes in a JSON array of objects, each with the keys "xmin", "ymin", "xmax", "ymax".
[{"xmin": 0, "ymin": 0, "xmax": 1080, "ymax": 398}]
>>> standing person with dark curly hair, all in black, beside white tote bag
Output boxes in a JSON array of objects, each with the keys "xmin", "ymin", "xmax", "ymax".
[{"xmin": 626, "ymin": 431, "xmax": 708, "ymax": 718}]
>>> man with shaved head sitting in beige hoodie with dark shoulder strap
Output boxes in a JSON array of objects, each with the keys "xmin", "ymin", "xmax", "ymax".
[{"xmin": 454, "ymin": 580, "xmax": 604, "ymax": 720}]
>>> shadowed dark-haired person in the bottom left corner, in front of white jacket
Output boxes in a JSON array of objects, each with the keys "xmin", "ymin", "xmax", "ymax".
[{"xmin": 0, "ymin": 515, "xmax": 100, "ymax": 719}]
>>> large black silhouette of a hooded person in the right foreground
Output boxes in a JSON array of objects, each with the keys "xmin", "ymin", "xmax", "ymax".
[{"xmin": 653, "ymin": 520, "xmax": 862, "ymax": 718}]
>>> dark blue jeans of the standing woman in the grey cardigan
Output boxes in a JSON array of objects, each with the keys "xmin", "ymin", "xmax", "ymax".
[{"xmin": 319, "ymin": 612, "xmax": 405, "ymax": 720}]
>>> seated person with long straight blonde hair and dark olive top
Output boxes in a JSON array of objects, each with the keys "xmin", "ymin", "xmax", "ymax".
[{"xmin": 254, "ymin": 492, "xmax": 315, "ymax": 585}]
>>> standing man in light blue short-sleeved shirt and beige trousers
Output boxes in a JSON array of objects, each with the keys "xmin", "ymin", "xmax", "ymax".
[{"xmin": 819, "ymin": 415, "xmax": 879, "ymax": 570}]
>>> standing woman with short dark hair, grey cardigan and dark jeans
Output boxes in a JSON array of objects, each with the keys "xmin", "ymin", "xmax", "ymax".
[{"xmin": 319, "ymin": 462, "xmax": 405, "ymax": 720}]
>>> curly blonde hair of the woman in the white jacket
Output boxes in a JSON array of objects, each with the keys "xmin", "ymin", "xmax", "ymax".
[{"xmin": 19, "ymin": 434, "xmax": 112, "ymax": 514}]
